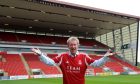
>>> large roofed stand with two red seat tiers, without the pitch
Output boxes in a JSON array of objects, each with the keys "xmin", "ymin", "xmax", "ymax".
[{"xmin": 0, "ymin": 0, "xmax": 140, "ymax": 80}]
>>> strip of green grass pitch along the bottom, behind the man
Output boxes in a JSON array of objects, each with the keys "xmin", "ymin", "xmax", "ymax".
[{"xmin": 0, "ymin": 75, "xmax": 140, "ymax": 84}]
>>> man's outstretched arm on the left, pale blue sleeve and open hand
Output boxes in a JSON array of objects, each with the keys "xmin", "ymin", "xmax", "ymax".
[{"xmin": 31, "ymin": 48, "xmax": 55, "ymax": 66}]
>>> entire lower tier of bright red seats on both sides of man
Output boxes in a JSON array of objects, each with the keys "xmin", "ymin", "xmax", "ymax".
[{"xmin": 0, "ymin": 53, "xmax": 140, "ymax": 75}]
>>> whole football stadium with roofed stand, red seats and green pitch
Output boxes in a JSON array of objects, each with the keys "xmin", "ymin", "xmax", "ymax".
[{"xmin": 0, "ymin": 0, "xmax": 140, "ymax": 84}]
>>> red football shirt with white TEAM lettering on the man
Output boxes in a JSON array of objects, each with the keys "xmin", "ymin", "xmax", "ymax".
[{"xmin": 53, "ymin": 52, "xmax": 94, "ymax": 84}]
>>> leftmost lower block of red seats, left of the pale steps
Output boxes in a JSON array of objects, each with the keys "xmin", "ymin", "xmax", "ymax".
[{"xmin": 0, "ymin": 54, "xmax": 27, "ymax": 76}]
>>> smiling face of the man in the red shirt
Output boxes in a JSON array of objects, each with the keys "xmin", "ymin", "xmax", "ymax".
[{"xmin": 68, "ymin": 40, "xmax": 79, "ymax": 55}]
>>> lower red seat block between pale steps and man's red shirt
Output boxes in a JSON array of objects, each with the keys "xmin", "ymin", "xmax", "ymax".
[{"xmin": 22, "ymin": 53, "xmax": 60, "ymax": 74}]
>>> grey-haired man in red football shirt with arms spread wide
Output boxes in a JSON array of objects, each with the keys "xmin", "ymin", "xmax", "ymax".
[{"xmin": 32, "ymin": 37, "xmax": 112, "ymax": 84}]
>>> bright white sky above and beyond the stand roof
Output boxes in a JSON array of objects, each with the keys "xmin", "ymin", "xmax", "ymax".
[{"xmin": 47, "ymin": 0, "xmax": 140, "ymax": 62}]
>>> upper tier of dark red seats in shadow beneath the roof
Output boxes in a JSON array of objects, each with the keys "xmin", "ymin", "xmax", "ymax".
[{"xmin": 0, "ymin": 32, "xmax": 107, "ymax": 48}]
